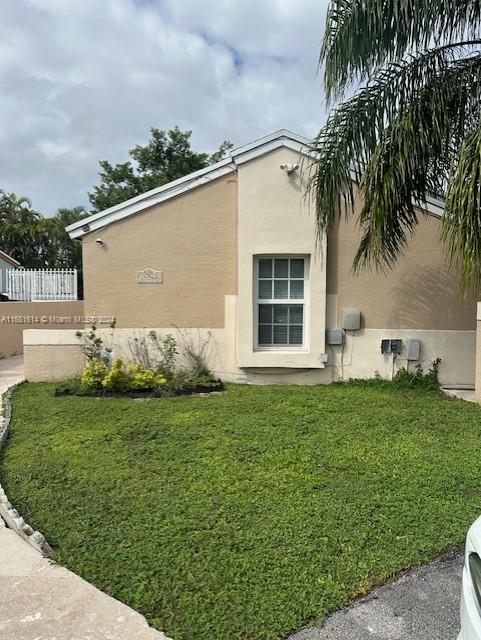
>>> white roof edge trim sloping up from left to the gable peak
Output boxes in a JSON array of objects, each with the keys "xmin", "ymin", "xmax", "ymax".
[{"xmin": 66, "ymin": 129, "xmax": 310, "ymax": 238}]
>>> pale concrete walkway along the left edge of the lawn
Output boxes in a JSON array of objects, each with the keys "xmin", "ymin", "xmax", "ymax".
[{"xmin": 0, "ymin": 356, "xmax": 171, "ymax": 640}]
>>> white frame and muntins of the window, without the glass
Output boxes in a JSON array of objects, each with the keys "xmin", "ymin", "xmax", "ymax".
[{"xmin": 253, "ymin": 253, "xmax": 310, "ymax": 353}]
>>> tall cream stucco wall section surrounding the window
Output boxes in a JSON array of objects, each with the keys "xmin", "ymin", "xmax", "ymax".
[{"xmin": 237, "ymin": 148, "xmax": 326, "ymax": 368}]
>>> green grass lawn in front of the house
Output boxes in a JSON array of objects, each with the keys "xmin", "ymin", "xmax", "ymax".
[{"xmin": 0, "ymin": 383, "xmax": 481, "ymax": 640}]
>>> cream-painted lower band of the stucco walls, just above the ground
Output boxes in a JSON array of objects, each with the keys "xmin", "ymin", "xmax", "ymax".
[{"xmin": 24, "ymin": 318, "xmax": 474, "ymax": 389}]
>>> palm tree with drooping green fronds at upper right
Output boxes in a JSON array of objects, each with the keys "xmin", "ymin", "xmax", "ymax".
[{"xmin": 310, "ymin": 0, "xmax": 481, "ymax": 288}]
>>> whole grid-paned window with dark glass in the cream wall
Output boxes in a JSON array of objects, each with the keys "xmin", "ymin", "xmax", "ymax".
[{"xmin": 256, "ymin": 257, "xmax": 307, "ymax": 348}]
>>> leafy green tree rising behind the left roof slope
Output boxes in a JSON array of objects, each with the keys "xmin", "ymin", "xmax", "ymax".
[{"xmin": 89, "ymin": 127, "xmax": 233, "ymax": 212}]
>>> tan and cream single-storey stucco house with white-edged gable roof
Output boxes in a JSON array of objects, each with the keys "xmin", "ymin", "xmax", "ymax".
[{"xmin": 59, "ymin": 130, "xmax": 476, "ymax": 386}]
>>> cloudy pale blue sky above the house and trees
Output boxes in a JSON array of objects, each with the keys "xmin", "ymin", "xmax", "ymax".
[{"xmin": 0, "ymin": 0, "xmax": 328, "ymax": 215}]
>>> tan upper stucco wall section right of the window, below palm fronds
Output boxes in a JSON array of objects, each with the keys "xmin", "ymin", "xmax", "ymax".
[{"xmin": 327, "ymin": 214, "xmax": 476, "ymax": 331}]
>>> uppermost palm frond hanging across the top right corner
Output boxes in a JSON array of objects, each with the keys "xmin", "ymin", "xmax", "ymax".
[{"xmin": 320, "ymin": 0, "xmax": 481, "ymax": 100}]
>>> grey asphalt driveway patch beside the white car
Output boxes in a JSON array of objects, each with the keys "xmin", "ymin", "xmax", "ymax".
[{"xmin": 290, "ymin": 551, "xmax": 464, "ymax": 640}]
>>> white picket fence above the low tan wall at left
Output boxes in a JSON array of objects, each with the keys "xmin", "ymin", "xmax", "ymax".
[{"xmin": 6, "ymin": 269, "xmax": 77, "ymax": 301}]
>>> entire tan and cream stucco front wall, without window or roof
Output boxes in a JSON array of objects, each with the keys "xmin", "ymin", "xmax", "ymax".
[{"xmin": 51, "ymin": 148, "xmax": 472, "ymax": 386}]
